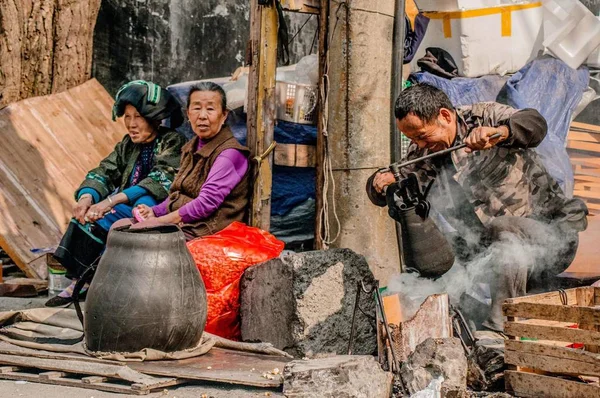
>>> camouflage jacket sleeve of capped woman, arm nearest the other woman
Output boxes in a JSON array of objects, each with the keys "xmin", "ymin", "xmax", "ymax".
[{"xmin": 138, "ymin": 131, "xmax": 186, "ymax": 201}]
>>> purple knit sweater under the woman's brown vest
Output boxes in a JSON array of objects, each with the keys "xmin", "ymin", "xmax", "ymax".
[{"xmin": 152, "ymin": 140, "xmax": 248, "ymax": 223}]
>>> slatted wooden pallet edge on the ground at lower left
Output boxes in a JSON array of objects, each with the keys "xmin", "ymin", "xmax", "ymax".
[{"xmin": 0, "ymin": 366, "xmax": 187, "ymax": 395}]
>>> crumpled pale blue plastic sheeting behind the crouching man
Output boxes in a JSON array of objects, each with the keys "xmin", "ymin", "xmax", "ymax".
[{"xmin": 411, "ymin": 56, "xmax": 589, "ymax": 196}]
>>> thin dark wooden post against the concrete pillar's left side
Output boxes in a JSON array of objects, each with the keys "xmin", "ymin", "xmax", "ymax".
[{"xmin": 315, "ymin": 0, "xmax": 329, "ymax": 250}]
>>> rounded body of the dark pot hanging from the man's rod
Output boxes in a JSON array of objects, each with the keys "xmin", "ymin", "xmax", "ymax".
[{"xmin": 399, "ymin": 207, "xmax": 454, "ymax": 278}]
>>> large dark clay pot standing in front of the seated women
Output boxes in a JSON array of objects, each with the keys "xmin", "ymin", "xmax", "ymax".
[{"xmin": 84, "ymin": 225, "xmax": 206, "ymax": 352}]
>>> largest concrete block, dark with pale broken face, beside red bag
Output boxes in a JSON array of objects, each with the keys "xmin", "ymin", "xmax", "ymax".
[{"xmin": 240, "ymin": 249, "xmax": 377, "ymax": 358}]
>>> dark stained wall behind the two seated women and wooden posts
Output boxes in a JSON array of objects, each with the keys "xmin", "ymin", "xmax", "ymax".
[{"xmin": 92, "ymin": 0, "xmax": 317, "ymax": 95}]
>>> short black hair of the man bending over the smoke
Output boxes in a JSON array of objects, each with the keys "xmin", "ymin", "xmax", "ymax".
[{"xmin": 394, "ymin": 83, "xmax": 454, "ymax": 123}]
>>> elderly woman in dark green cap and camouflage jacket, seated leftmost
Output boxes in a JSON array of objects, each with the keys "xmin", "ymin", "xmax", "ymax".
[{"xmin": 46, "ymin": 80, "xmax": 186, "ymax": 307}]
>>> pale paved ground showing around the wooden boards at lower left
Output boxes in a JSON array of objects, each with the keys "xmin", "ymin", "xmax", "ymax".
[{"xmin": 0, "ymin": 297, "xmax": 283, "ymax": 398}]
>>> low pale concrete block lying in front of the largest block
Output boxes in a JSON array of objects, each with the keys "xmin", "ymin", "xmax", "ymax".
[{"xmin": 283, "ymin": 355, "xmax": 392, "ymax": 398}]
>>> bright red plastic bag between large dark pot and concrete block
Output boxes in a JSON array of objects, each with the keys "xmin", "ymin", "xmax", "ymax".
[{"xmin": 187, "ymin": 222, "xmax": 284, "ymax": 339}]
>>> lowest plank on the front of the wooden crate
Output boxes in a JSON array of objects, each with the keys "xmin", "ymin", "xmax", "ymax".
[{"xmin": 504, "ymin": 370, "xmax": 600, "ymax": 398}]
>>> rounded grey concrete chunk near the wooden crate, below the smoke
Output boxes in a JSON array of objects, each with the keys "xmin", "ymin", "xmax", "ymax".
[{"xmin": 400, "ymin": 338, "xmax": 467, "ymax": 394}]
